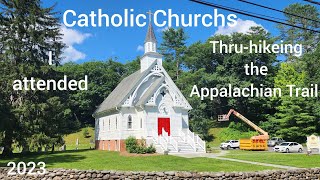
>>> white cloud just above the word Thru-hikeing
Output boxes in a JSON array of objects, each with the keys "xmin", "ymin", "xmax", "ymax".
[{"xmin": 214, "ymin": 18, "xmax": 263, "ymax": 35}]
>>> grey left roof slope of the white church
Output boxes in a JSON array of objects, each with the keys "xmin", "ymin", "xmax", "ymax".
[{"xmin": 93, "ymin": 62, "xmax": 156, "ymax": 115}]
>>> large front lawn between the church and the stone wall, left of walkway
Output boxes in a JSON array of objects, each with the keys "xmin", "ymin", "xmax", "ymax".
[{"xmin": 0, "ymin": 150, "xmax": 272, "ymax": 172}]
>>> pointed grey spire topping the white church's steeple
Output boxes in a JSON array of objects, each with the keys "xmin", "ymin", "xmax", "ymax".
[{"xmin": 144, "ymin": 11, "xmax": 157, "ymax": 53}]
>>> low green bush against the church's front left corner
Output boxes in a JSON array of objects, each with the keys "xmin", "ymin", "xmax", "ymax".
[{"xmin": 125, "ymin": 136, "xmax": 156, "ymax": 154}]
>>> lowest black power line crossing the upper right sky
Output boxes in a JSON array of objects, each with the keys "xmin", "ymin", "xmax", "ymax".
[{"xmin": 190, "ymin": 0, "xmax": 320, "ymax": 33}]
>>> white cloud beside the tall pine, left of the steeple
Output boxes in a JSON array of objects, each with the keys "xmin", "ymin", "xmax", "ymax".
[{"xmin": 61, "ymin": 25, "xmax": 92, "ymax": 63}]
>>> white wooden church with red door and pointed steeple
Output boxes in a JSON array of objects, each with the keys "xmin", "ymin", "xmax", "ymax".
[{"xmin": 93, "ymin": 20, "xmax": 206, "ymax": 153}]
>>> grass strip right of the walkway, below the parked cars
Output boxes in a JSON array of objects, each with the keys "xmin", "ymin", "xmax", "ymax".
[{"xmin": 225, "ymin": 150, "xmax": 320, "ymax": 168}]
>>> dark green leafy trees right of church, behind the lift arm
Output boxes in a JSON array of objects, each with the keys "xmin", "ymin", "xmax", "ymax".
[{"xmin": 177, "ymin": 27, "xmax": 277, "ymax": 139}]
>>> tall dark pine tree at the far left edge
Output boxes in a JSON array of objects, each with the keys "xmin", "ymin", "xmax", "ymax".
[{"xmin": 0, "ymin": 0, "xmax": 64, "ymax": 155}]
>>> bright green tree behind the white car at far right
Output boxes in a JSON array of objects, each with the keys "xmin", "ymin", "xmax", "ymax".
[{"xmin": 271, "ymin": 63, "xmax": 317, "ymax": 142}]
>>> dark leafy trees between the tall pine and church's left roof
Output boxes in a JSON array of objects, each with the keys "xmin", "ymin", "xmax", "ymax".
[{"xmin": 57, "ymin": 59, "xmax": 127, "ymax": 126}]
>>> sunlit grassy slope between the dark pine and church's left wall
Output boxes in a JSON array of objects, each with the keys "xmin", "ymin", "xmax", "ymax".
[{"xmin": 63, "ymin": 127, "xmax": 94, "ymax": 150}]
